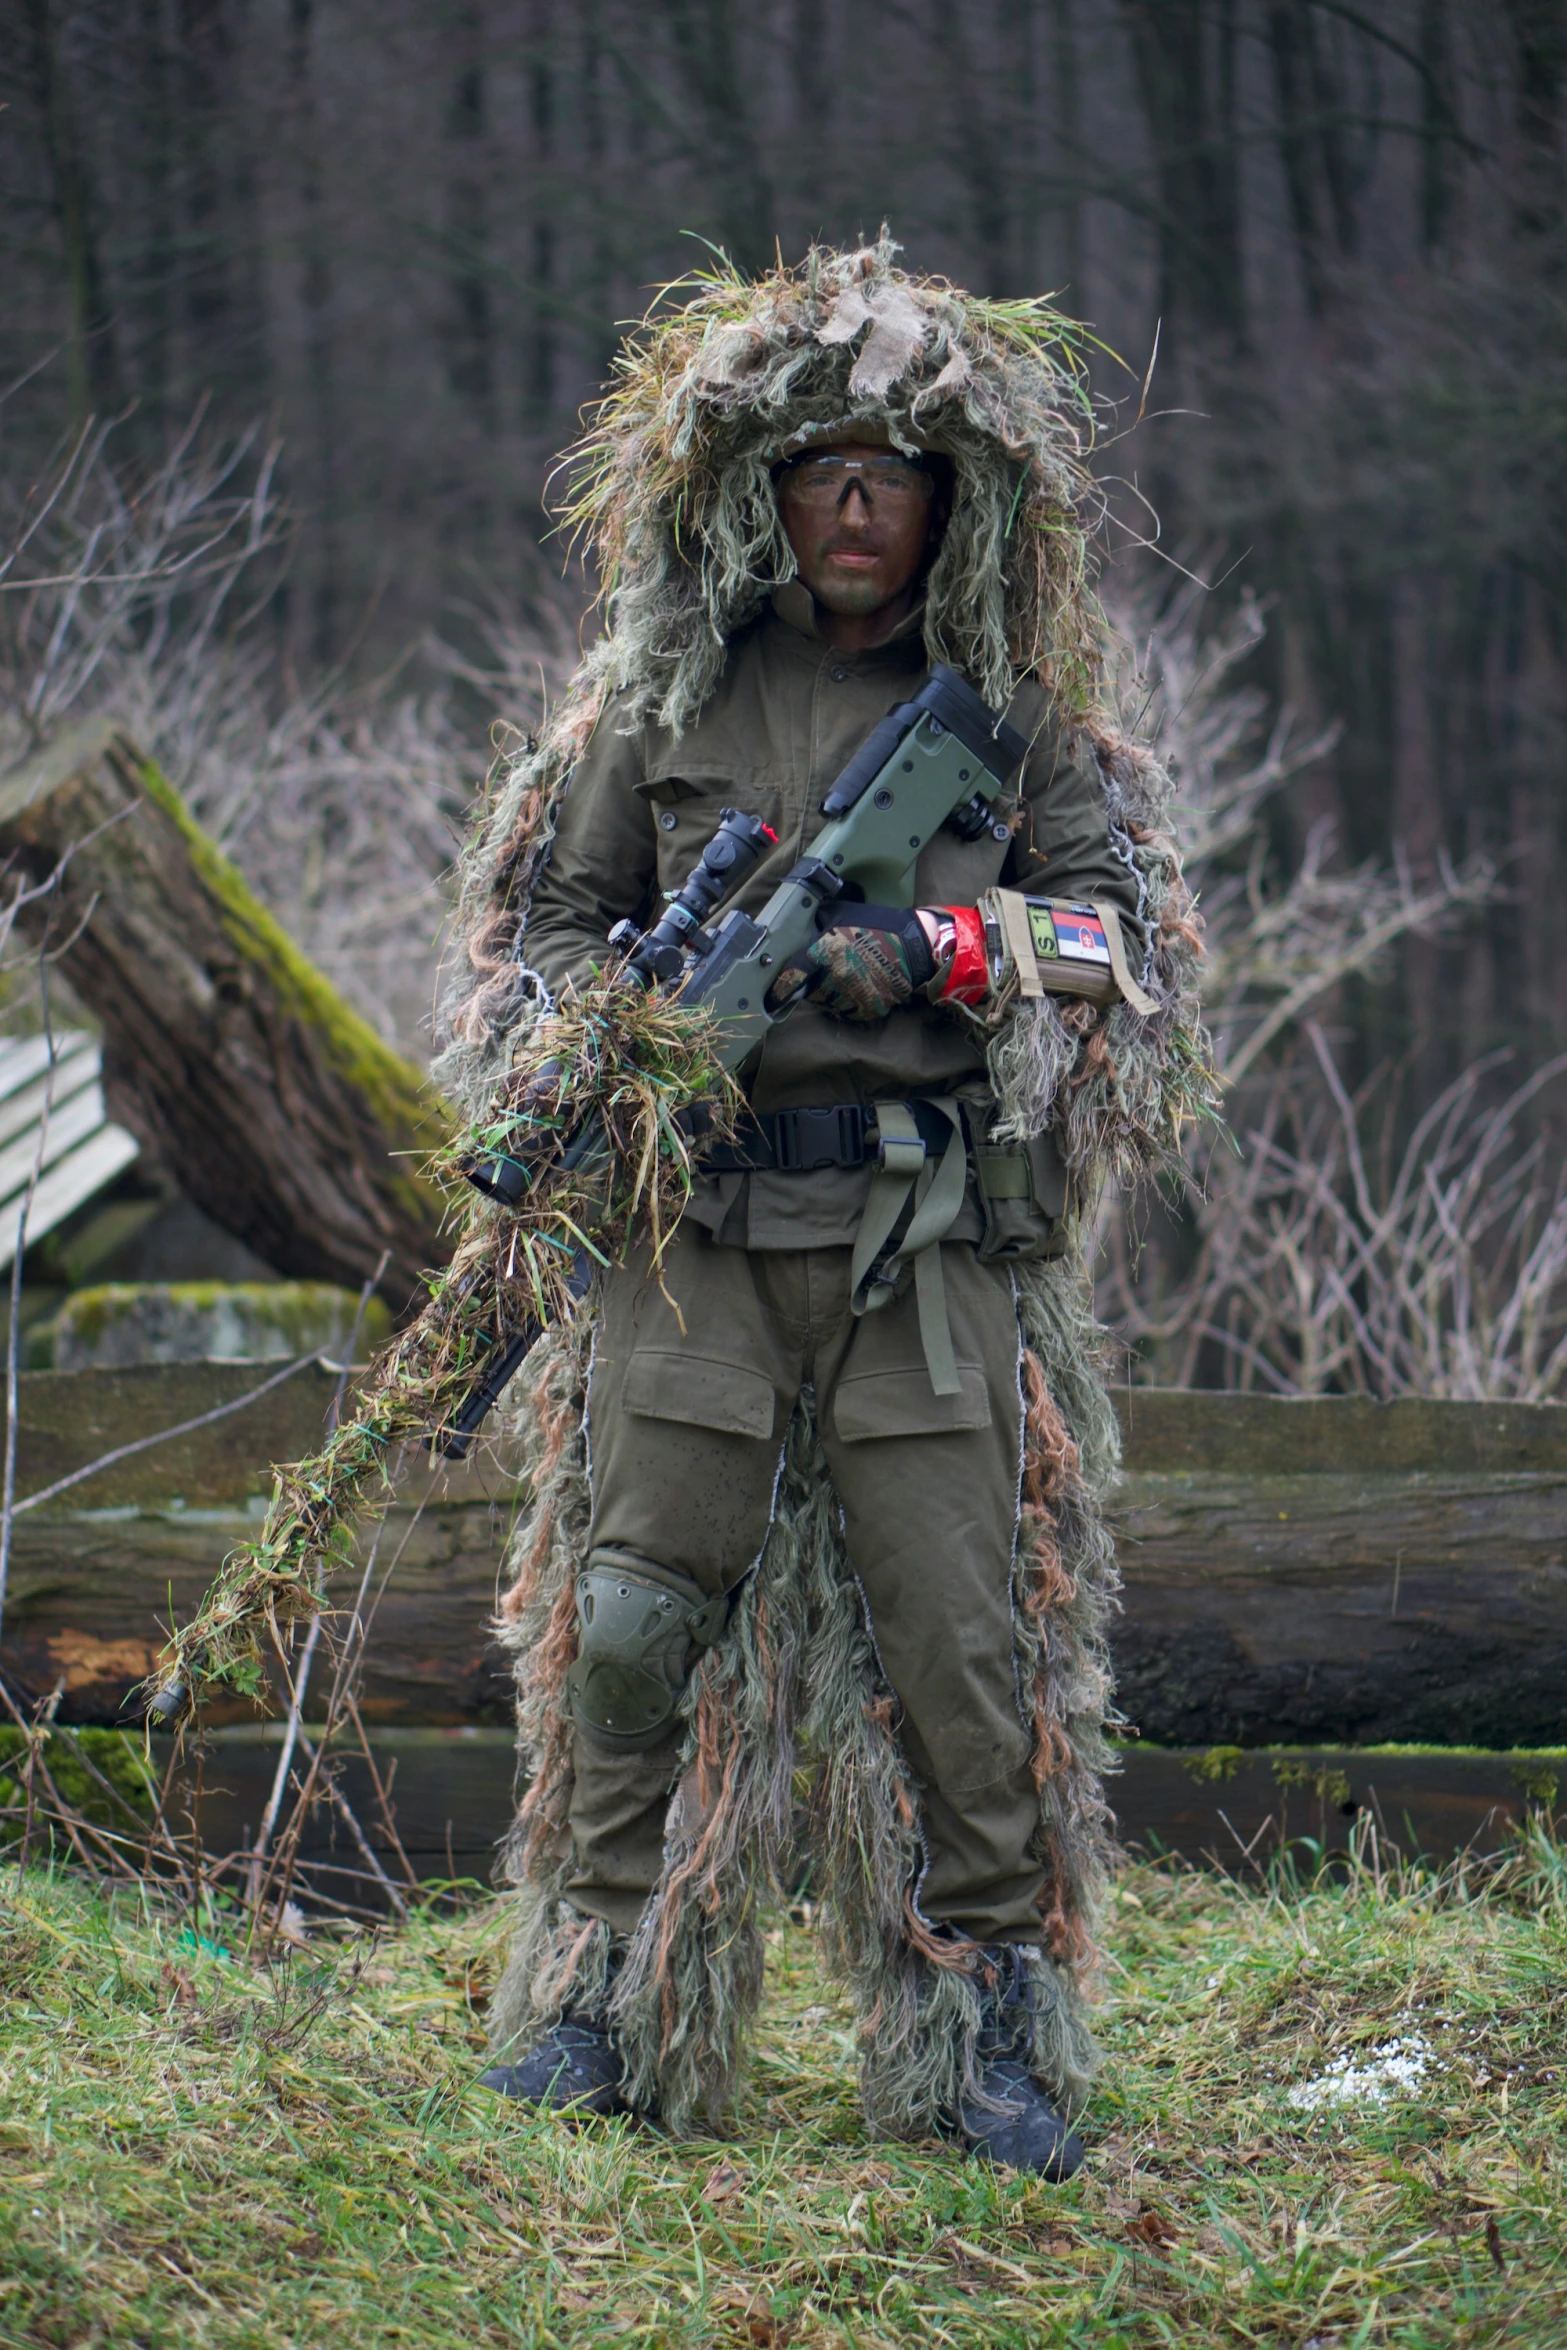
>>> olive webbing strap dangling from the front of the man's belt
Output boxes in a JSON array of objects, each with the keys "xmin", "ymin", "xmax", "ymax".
[{"xmin": 848, "ymin": 1095, "xmax": 968, "ymax": 1396}]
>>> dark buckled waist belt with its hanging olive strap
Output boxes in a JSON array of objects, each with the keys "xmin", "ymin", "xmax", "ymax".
[{"xmin": 681, "ymin": 1095, "xmax": 1029, "ymax": 1396}]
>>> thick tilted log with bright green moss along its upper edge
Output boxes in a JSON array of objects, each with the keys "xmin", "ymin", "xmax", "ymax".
[{"xmin": 0, "ymin": 719, "xmax": 449, "ymax": 1311}]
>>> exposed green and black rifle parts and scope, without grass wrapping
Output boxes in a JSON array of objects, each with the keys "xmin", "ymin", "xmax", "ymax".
[{"xmin": 437, "ymin": 665, "xmax": 1029, "ymax": 1459}]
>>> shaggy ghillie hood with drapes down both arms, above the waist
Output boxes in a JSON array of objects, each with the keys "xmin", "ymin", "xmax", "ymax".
[{"xmin": 437, "ymin": 233, "xmax": 1205, "ymax": 1191}]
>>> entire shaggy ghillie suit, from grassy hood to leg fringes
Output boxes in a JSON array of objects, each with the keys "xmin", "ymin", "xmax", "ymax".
[{"xmin": 437, "ymin": 237, "xmax": 1210, "ymax": 2134}]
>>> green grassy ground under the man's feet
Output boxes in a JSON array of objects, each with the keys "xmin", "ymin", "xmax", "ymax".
[{"xmin": 0, "ymin": 1842, "xmax": 1567, "ymax": 2350}]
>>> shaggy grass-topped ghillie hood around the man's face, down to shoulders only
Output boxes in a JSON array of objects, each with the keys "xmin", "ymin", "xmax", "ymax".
[{"xmin": 564, "ymin": 235, "xmax": 1099, "ymax": 733}]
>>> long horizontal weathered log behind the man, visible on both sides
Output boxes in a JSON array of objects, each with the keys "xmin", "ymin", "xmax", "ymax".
[{"xmin": 2, "ymin": 1363, "xmax": 1567, "ymax": 1748}]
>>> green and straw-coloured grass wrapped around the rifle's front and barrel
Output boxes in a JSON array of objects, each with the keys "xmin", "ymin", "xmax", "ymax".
[{"xmin": 153, "ymin": 980, "xmax": 738, "ymax": 1706}]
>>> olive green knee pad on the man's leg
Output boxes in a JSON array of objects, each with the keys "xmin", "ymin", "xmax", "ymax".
[{"xmin": 566, "ymin": 1556, "xmax": 728, "ymax": 1751}]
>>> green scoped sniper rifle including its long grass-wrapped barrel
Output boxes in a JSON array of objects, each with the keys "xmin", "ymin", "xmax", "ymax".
[{"xmin": 148, "ymin": 667, "xmax": 1029, "ymax": 1723}]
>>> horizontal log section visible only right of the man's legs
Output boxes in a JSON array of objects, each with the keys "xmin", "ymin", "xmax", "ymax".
[{"xmin": 1114, "ymin": 1389, "xmax": 1567, "ymax": 1746}]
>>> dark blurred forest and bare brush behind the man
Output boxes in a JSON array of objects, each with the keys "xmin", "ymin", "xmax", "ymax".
[{"xmin": 0, "ymin": 0, "xmax": 1567, "ymax": 1394}]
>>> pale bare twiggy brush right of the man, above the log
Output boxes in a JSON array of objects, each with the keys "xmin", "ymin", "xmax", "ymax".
[{"xmin": 1097, "ymin": 566, "xmax": 1567, "ymax": 1401}]
